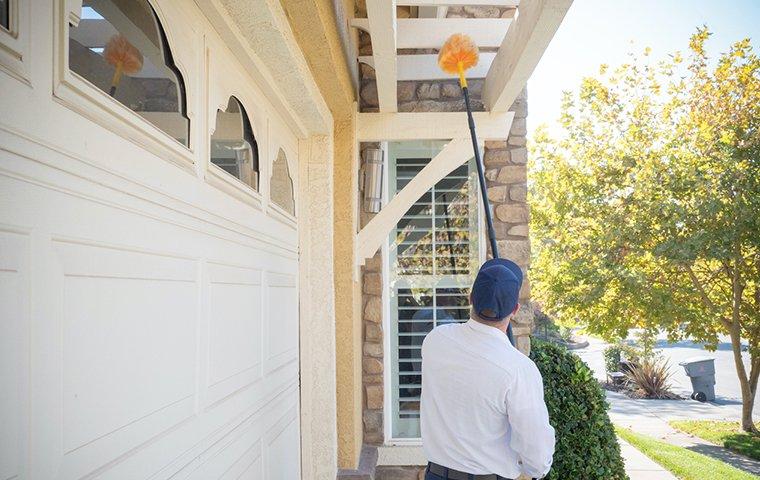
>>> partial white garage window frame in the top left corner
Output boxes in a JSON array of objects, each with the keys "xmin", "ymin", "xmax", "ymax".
[{"xmin": 0, "ymin": 0, "xmax": 33, "ymax": 83}]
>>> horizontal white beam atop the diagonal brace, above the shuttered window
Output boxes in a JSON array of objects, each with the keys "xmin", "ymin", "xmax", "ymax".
[{"xmin": 356, "ymin": 112, "xmax": 515, "ymax": 142}]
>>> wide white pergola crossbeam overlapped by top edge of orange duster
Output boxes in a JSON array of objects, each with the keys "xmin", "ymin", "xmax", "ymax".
[{"xmin": 351, "ymin": 16, "xmax": 512, "ymax": 51}]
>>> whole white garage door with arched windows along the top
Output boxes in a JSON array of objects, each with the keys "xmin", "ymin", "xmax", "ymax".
[{"xmin": 0, "ymin": 0, "xmax": 300, "ymax": 480}]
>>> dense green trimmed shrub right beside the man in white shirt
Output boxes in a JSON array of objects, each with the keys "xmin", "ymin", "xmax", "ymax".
[{"xmin": 530, "ymin": 339, "xmax": 628, "ymax": 480}]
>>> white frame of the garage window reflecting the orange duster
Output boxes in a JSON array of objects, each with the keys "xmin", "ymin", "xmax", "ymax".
[{"xmin": 52, "ymin": 0, "xmax": 196, "ymax": 174}]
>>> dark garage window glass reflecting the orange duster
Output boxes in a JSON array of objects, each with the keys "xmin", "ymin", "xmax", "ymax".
[{"xmin": 69, "ymin": 0, "xmax": 190, "ymax": 146}]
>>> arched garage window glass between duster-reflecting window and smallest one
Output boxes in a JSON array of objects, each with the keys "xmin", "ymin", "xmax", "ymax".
[{"xmin": 211, "ymin": 97, "xmax": 259, "ymax": 191}]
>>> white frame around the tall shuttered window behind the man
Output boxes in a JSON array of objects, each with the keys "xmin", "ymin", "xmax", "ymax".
[{"xmin": 381, "ymin": 142, "xmax": 487, "ymax": 447}]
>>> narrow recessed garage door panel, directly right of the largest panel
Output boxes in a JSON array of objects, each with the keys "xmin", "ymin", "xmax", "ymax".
[{"xmin": 207, "ymin": 263, "xmax": 264, "ymax": 404}]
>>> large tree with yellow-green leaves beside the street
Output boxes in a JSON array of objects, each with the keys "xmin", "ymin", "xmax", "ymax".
[{"xmin": 530, "ymin": 28, "xmax": 760, "ymax": 431}]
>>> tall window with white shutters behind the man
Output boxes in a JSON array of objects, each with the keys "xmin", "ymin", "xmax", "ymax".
[{"xmin": 388, "ymin": 141, "xmax": 480, "ymax": 439}]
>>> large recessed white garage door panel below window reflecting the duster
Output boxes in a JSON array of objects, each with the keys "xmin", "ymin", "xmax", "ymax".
[{"xmin": 54, "ymin": 241, "xmax": 198, "ymax": 463}]
